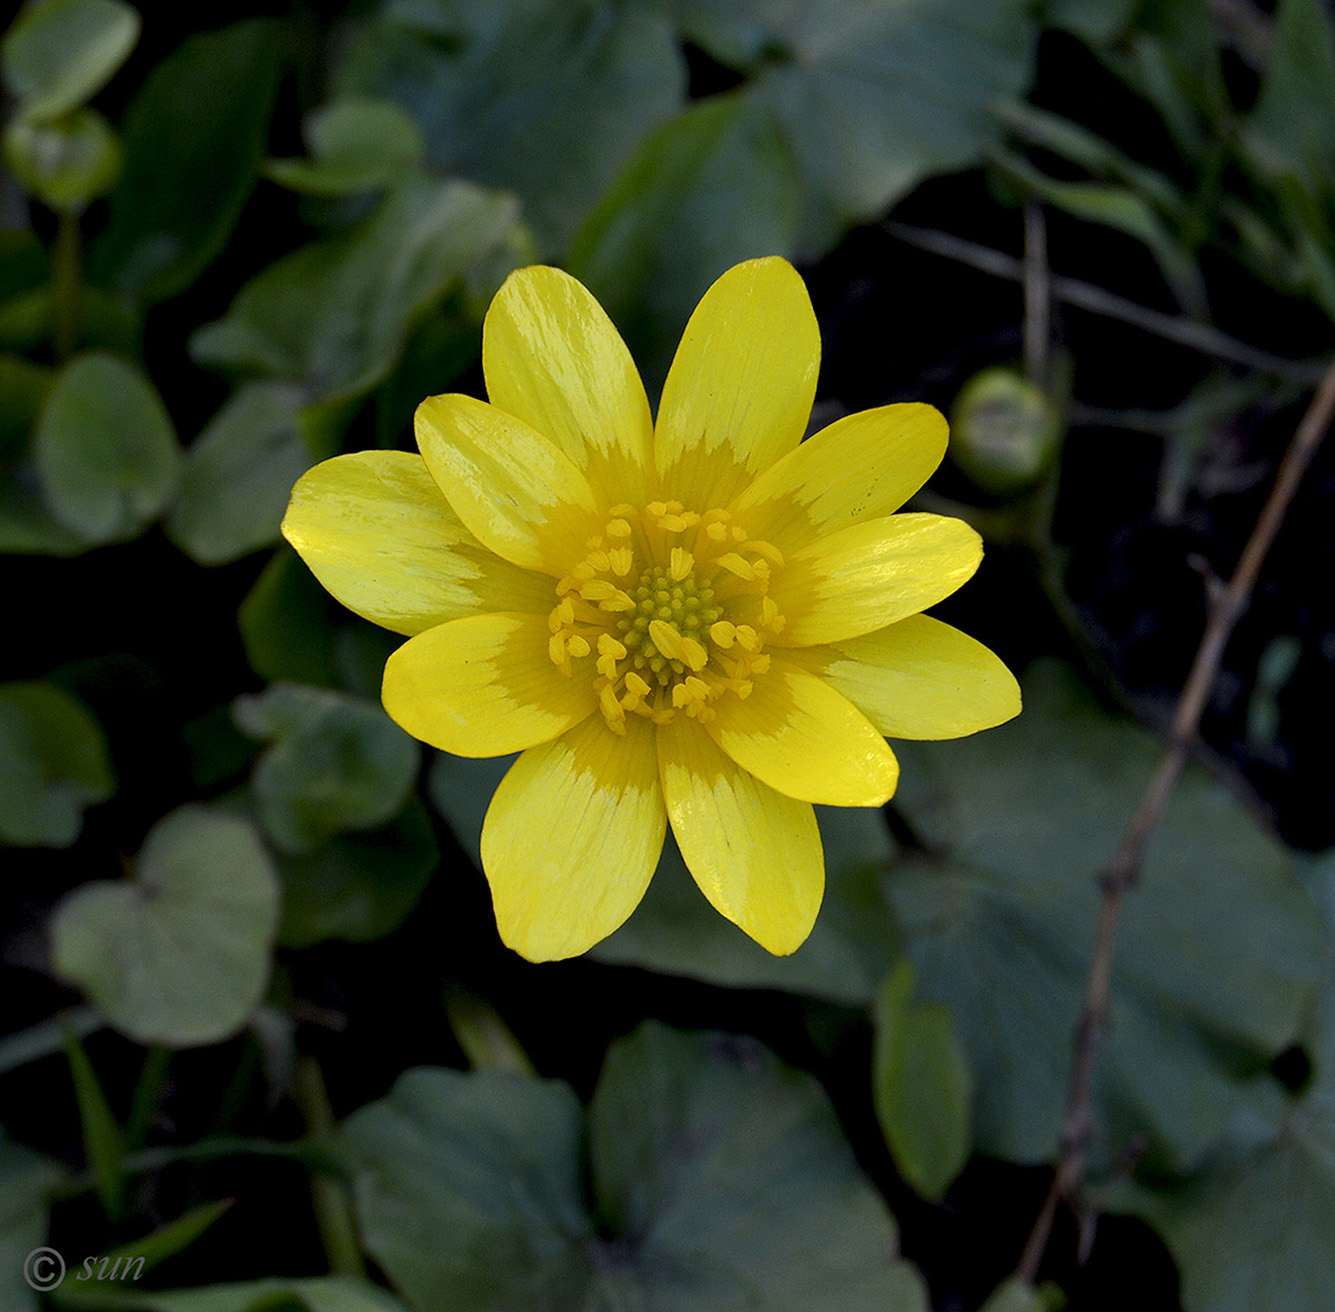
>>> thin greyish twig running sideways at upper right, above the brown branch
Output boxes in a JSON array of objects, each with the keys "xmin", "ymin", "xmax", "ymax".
[{"xmin": 882, "ymin": 219, "xmax": 1326, "ymax": 386}]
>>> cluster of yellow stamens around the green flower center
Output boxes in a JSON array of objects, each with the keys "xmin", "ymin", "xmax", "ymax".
[{"xmin": 547, "ymin": 502, "xmax": 784, "ymax": 734}]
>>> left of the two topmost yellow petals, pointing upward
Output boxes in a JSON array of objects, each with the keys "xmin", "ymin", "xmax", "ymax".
[{"xmin": 482, "ymin": 266, "xmax": 653, "ymax": 505}]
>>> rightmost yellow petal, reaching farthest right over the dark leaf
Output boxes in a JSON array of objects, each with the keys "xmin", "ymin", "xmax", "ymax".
[{"xmin": 785, "ymin": 615, "xmax": 1020, "ymax": 738}]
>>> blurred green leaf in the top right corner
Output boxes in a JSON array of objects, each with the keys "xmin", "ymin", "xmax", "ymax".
[{"xmin": 1243, "ymin": 0, "xmax": 1335, "ymax": 194}]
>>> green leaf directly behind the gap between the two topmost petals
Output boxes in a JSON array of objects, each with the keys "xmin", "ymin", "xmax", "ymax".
[{"xmin": 569, "ymin": 95, "xmax": 801, "ymax": 383}]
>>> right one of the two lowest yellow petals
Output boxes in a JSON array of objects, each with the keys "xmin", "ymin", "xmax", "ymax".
[{"xmin": 658, "ymin": 715, "xmax": 825, "ymax": 956}]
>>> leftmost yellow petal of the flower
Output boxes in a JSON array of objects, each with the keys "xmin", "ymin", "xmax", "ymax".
[{"xmin": 283, "ymin": 451, "xmax": 553, "ymax": 634}]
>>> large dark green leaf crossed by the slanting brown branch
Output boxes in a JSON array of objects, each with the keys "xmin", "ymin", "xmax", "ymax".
[{"xmin": 888, "ymin": 666, "xmax": 1322, "ymax": 1167}]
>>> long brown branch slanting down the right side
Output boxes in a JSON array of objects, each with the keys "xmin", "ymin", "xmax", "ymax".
[{"xmin": 1016, "ymin": 362, "xmax": 1335, "ymax": 1284}]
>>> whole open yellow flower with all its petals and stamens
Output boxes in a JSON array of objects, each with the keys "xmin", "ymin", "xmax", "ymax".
[{"xmin": 283, "ymin": 259, "xmax": 1020, "ymax": 961}]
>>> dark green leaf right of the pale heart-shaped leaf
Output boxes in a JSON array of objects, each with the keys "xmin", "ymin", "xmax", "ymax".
[{"xmin": 278, "ymin": 798, "xmax": 441, "ymax": 948}]
